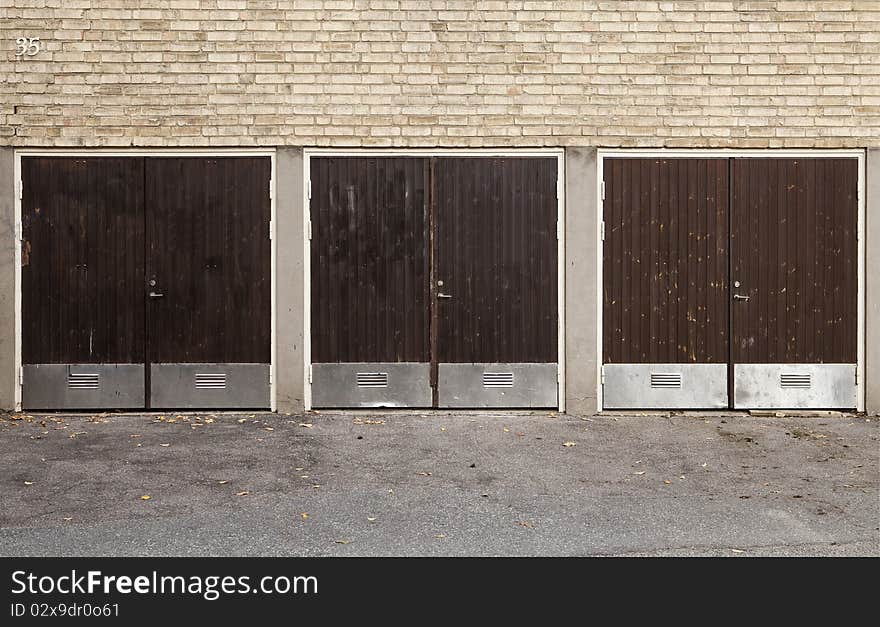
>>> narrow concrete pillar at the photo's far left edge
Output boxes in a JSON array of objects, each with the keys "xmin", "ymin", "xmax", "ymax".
[{"xmin": 0, "ymin": 148, "xmax": 16, "ymax": 410}]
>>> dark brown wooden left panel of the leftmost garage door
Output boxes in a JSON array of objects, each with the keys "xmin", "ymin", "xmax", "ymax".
[{"xmin": 21, "ymin": 157, "xmax": 144, "ymax": 364}]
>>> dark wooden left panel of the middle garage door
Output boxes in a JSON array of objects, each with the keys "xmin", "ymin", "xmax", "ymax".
[{"xmin": 311, "ymin": 157, "xmax": 430, "ymax": 363}]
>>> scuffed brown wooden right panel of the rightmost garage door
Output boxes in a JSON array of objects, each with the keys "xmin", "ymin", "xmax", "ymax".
[{"xmin": 731, "ymin": 158, "xmax": 858, "ymax": 363}]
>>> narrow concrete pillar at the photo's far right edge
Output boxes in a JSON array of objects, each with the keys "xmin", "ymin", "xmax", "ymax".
[{"xmin": 865, "ymin": 148, "xmax": 880, "ymax": 415}]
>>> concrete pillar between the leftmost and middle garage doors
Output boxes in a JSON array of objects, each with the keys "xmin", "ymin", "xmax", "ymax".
[{"xmin": 275, "ymin": 148, "xmax": 306, "ymax": 413}]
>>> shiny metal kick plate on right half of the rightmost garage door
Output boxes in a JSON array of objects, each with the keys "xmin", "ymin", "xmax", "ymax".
[{"xmin": 733, "ymin": 364, "xmax": 858, "ymax": 409}]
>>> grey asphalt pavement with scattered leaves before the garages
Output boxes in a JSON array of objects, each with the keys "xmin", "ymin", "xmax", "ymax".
[{"xmin": 0, "ymin": 412, "xmax": 880, "ymax": 557}]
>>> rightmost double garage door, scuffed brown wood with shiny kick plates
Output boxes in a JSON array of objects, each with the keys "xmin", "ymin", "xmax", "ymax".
[{"xmin": 602, "ymin": 158, "xmax": 858, "ymax": 408}]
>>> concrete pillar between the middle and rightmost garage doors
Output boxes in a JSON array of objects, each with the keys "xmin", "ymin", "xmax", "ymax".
[{"xmin": 565, "ymin": 147, "xmax": 600, "ymax": 415}]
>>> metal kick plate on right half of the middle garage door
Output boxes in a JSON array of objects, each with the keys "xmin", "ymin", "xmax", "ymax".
[{"xmin": 437, "ymin": 364, "xmax": 559, "ymax": 409}]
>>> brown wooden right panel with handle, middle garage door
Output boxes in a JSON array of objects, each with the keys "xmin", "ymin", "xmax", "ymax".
[{"xmin": 432, "ymin": 157, "xmax": 558, "ymax": 363}]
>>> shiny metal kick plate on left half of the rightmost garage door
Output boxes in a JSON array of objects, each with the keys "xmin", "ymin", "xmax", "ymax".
[{"xmin": 602, "ymin": 364, "xmax": 727, "ymax": 409}]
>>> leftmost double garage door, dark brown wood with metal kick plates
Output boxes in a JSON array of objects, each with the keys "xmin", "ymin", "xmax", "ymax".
[{"xmin": 22, "ymin": 157, "xmax": 271, "ymax": 409}]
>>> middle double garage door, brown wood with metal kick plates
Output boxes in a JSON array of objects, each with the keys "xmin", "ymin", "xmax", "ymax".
[{"xmin": 310, "ymin": 157, "xmax": 558, "ymax": 407}]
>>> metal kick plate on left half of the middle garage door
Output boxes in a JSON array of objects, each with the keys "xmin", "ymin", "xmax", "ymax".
[{"xmin": 312, "ymin": 362, "xmax": 431, "ymax": 408}]
